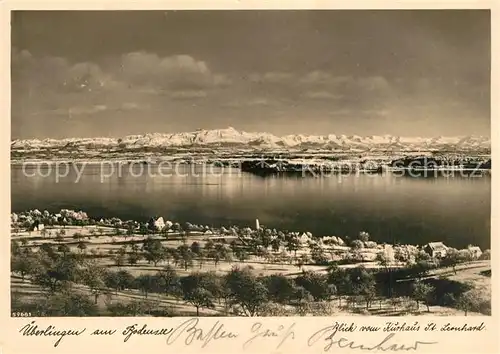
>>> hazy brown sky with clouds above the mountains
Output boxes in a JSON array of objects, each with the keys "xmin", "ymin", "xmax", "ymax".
[{"xmin": 11, "ymin": 10, "xmax": 491, "ymax": 139}]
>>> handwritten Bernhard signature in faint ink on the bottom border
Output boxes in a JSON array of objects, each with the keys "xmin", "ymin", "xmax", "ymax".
[{"xmin": 307, "ymin": 326, "xmax": 437, "ymax": 352}]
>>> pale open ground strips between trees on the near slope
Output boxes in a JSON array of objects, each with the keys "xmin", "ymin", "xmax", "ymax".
[{"xmin": 11, "ymin": 226, "xmax": 491, "ymax": 316}]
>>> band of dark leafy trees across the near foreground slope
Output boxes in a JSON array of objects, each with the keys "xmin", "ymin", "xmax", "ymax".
[{"xmin": 12, "ymin": 241, "xmax": 484, "ymax": 316}]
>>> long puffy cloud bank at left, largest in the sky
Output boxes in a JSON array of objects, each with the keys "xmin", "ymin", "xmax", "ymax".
[{"xmin": 12, "ymin": 49, "xmax": 232, "ymax": 96}]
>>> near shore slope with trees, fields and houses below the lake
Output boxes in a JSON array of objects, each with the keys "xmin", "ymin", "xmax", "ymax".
[{"xmin": 11, "ymin": 209, "xmax": 491, "ymax": 316}]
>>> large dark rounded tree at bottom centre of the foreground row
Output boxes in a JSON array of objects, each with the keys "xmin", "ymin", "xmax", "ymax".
[{"xmin": 226, "ymin": 267, "xmax": 267, "ymax": 316}]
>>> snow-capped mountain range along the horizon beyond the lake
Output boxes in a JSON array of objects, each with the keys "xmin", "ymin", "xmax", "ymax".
[{"xmin": 11, "ymin": 127, "xmax": 491, "ymax": 151}]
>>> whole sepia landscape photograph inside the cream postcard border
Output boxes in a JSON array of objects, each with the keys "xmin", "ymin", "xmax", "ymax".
[{"xmin": 10, "ymin": 9, "xmax": 492, "ymax": 318}]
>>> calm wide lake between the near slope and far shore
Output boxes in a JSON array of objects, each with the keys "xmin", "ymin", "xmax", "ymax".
[{"xmin": 11, "ymin": 164, "xmax": 491, "ymax": 249}]
